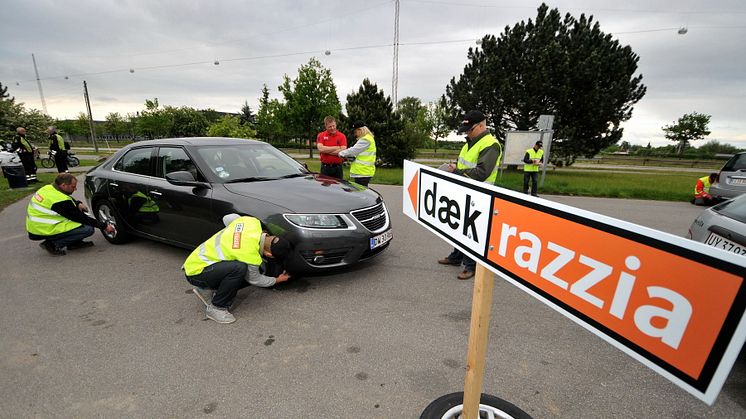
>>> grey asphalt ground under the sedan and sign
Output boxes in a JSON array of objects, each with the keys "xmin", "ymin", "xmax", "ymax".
[{"xmin": 0, "ymin": 185, "xmax": 746, "ymax": 418}]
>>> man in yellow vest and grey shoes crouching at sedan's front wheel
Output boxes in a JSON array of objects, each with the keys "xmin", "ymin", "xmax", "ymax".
[{"xmin": 181, "ymin": 214, "xmax": 292, "ymax": 324}]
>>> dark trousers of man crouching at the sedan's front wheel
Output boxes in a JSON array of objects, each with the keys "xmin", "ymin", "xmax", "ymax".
[{"xmin": 186, "ymin": 260, "xmax": 249, "ymax": 310}]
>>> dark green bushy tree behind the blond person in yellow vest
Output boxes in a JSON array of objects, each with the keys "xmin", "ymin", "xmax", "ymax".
[{"xmin": 345, "ymin": 78, "xmax": 404, "ymax": 167}]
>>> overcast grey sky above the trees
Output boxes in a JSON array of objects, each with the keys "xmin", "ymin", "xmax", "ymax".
[{"xmin": 0, "ymin": 0, "xmax": 746, "ymax": 148}]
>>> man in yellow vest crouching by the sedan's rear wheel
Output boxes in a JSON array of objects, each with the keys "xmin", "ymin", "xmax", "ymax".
[{"xmin": 26, "ymin": 173, "xmax": 115, "ymax": 256}]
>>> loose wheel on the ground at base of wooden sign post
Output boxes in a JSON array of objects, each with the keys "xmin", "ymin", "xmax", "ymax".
[{"xmin": 420, "ymin": 392, "xmax": 531, "ymax": 419}]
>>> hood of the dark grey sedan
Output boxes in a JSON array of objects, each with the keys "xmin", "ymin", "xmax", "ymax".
[{"xmin": 224, "ymin": 174, "xmax": 382, "ymax": 213}]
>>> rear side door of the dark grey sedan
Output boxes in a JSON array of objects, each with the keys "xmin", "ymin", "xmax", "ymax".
[{"xmin": 107, "ymin": 147, "xmax": 156, "ymax": 233}]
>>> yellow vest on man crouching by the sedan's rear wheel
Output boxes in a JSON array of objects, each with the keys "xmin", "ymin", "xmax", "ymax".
[{"xmin": 26, "ymin": 185, "xmax": 81, "ymax": 236}]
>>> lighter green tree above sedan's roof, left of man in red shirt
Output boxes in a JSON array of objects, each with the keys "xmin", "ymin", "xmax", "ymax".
[{"xmin": 278, "ymin": 58, "xmax": 342, "ymax": 157}]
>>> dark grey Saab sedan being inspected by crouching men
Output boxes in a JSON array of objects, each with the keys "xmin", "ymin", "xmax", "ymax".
[{"xmin": 85, "ymin": 138, "xmax": 392, "ymax": 274}]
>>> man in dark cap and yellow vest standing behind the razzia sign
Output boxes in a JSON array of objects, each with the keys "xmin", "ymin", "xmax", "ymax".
[{"xmin": 438, "ymin": 111, "xmax": 503, "ymax": 279}]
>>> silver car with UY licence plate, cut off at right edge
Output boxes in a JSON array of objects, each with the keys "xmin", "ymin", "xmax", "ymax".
[{"xmin": 687, "ymin": 194, "xmax": 746, "ymax": 255}]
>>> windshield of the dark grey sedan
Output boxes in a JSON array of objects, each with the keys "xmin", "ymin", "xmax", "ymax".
[{"xmin": 197, "ymin": 144, "xmax": 308, "ymax": 183}]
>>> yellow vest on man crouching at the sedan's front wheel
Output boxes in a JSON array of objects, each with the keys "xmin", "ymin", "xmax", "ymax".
[{"xmin": 182, "ymin": 216, "xmax": 262, "ymax": 276}]
